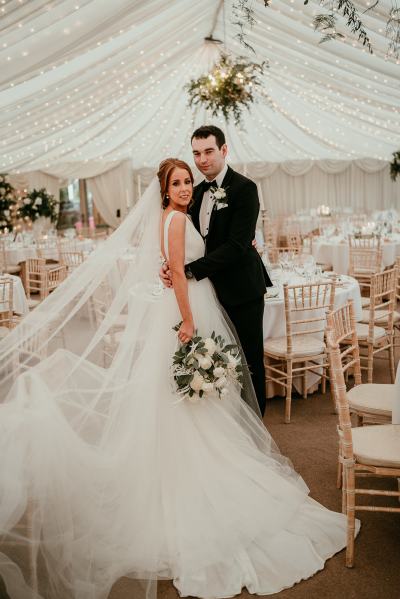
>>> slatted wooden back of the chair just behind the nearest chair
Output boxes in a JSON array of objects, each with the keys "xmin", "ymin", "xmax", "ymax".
[{"xmin": 326, "ymin": 300, "xmax": 361, "ymax": 385}]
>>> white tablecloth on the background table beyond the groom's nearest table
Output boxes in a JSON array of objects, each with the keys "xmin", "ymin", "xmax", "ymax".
[{"xmin": 312, "ymin": 237, "xmax": 400, "ymax": 275}]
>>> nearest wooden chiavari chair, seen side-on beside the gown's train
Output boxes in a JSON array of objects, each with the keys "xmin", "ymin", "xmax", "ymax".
[{"xmin": 327, "ymin": 329, "xmax": 400, "ymax": 568}]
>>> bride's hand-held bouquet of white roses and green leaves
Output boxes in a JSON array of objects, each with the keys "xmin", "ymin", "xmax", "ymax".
[{"xmin": 172, "ymin": 323, "xmax": 243, "ymax": 402}]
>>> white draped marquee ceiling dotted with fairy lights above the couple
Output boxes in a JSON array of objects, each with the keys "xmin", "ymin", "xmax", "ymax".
[{"xmin": 0, "ymin": 0, "xmax": 400, "ymax": 176}]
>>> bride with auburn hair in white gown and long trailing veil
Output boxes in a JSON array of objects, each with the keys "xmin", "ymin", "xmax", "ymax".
[{"xmin": 0, "ymin": 159, "xmax": 356, "ymax": 599}]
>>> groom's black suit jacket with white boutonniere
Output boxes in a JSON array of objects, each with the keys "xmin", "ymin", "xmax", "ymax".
[{"xmin": 188, "ymin": 167, "xmax": 272, "ymax": 306}]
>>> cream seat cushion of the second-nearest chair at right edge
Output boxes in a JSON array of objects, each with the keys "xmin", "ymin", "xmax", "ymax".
[{"xmin": 347, "ymin": 383, "xmax": 396, "ymax": 417}]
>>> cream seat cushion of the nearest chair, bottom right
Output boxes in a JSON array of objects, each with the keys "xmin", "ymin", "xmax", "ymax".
[{"xmin": 351, "ymin": 424, "xmax": 400, "ymax": 468}]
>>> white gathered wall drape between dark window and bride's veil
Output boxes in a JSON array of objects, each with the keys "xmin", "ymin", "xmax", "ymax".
[{"xmin": 86, "ymin": 160, "xmax": 135, "ymax": 227}]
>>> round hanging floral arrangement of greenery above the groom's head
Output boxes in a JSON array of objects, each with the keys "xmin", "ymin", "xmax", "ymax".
[{"xmin": 186, "ymin": 54, "xmax": 268, "ymax": 124}]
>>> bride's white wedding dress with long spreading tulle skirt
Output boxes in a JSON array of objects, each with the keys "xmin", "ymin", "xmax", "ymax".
[{"xmin": 0, "ymin": 190, "xmax": 356, "ymax": 599}]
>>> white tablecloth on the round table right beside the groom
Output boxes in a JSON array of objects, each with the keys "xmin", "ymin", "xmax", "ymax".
[{"xmin": 263, "ymin": 275, "xmax": 362, "ymax": 397}]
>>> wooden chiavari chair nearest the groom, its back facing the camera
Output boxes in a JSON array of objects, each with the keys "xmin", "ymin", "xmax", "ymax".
[{"xmin": 264, "ymin": 281, "xmax": 336, "ymax": 423}]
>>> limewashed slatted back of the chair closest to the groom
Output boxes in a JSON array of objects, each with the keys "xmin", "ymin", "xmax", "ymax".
[{"xmin": 283, "ymin": 280, "xmax": 336, "ymax": 355}]
